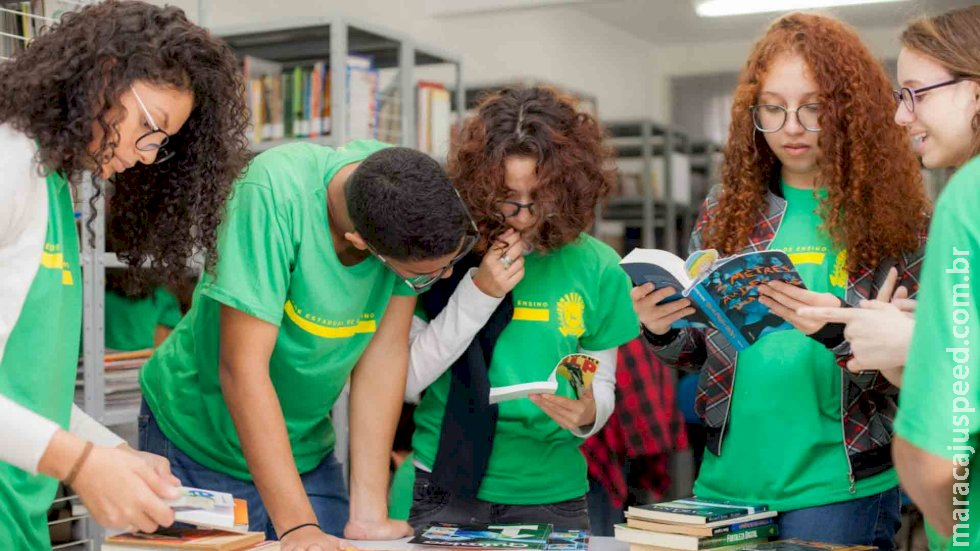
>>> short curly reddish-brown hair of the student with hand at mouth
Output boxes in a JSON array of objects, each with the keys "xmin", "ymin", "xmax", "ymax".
[{"xmin": 447, "ymin": 87, "xmax": 615, "ymax": 251}]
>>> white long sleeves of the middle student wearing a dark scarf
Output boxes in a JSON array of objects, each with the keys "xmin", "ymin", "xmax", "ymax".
[{"xmin": 405, "ymin": 268, "xmax": 618, "ymax": 438}]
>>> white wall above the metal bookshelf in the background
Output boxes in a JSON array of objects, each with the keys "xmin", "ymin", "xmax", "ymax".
[{"xmin": 167, "ymin": 0, "xmax": 657, "ymax": 119}]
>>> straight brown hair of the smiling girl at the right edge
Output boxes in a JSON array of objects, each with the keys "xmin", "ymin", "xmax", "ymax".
[{"xmin": 901, "ymin": 6, "xmax": 980, "ymax": 161}]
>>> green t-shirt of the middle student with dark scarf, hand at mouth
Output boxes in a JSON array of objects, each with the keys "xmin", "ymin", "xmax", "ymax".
[{"xmin": 412, "ymin": 234, "xmax": 639, "ymax": 505}]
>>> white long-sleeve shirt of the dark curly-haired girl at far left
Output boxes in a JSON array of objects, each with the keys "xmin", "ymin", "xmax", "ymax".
[{"xmin": 0, "ymin": 125, "xmax": 124, "ymax": 474}]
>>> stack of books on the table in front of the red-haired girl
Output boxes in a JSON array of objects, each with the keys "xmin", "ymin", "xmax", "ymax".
[{"xmin": 616, "ymin": 498, "xmax": 779, "ymax": 551}]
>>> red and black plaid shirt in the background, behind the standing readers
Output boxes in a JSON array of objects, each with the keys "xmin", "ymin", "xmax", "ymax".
[{"xmin": 582, "ymin": 338, "xmax": 687, "ymax": 507}]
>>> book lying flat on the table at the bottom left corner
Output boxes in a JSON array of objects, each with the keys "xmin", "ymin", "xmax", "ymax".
[{"xmin": 102, "ymin": 528, "xmax": 270, "ymax": 551}]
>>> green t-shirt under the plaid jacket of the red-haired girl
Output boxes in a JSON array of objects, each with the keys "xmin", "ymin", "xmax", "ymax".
[{"xmin": 694, "ymin": 183, "xmax": 898, "ymax": 511}]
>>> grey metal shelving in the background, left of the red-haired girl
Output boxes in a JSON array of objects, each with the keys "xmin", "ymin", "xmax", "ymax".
[{"xmin": 601, "ymin": 119, "xmax": 692, "ymax": 252}]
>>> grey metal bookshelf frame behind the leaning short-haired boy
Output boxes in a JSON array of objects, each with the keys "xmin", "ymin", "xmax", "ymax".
[{"xmin": 214, "ymin": 17, "xmax": 463, "ymax": 150}]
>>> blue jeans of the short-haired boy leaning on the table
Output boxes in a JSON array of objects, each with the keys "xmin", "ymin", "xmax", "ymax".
[{"xmin": 139, "ymin": 401, "xmax": 350, "ymax": 539}]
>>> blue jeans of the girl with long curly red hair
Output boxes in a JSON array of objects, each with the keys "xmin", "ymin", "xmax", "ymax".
[{"xmin": 779, "ymin": 487, "xmax": 902, "ymax": 551}]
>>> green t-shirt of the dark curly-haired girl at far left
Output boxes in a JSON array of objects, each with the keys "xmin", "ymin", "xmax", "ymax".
[{"xmin": 0, "ymin": 170, "xmax": 82, "ymax": 550}]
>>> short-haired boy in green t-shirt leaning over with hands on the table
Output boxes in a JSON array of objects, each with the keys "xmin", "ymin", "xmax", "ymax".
[{"xmin": 140, "ymin": 141, "xmax": 476, "ymax": 550}]
